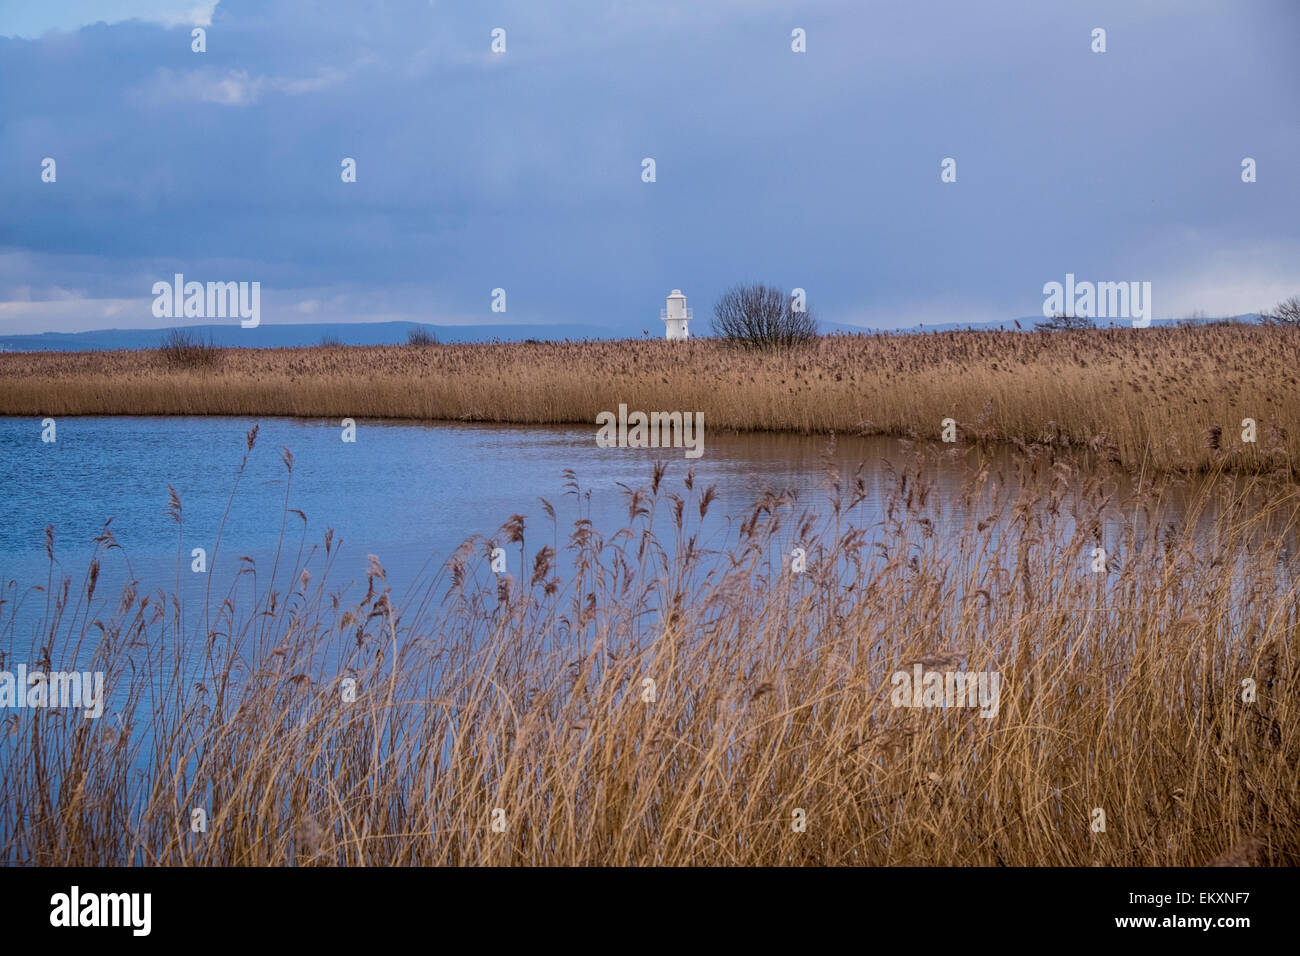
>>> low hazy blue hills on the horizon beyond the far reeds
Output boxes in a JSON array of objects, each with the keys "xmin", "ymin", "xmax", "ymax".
[{"xmin": 0, "ymin": 312, "xmax": 1260, "ymax": 352}]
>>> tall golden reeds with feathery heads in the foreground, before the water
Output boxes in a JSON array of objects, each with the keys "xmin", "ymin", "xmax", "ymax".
[{"xmin": 0, "ymin": 434, "xmax": 1300, "ymax": 866}]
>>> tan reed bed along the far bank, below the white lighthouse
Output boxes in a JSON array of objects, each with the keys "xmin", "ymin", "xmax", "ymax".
[{"xmin": 0, "ymin": 325, "xmax": 1300, "ymax": 476}]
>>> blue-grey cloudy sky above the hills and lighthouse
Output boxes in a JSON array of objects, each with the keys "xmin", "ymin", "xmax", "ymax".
[{"xmin": 0, "ymin": 0, "xmax": 1300, "ymax": 336}]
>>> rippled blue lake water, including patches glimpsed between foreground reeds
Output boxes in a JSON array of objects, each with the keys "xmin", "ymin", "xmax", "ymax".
[{"xmin": 0, "ymin": 418, "xmax": 1295, "ymax": 770}]
